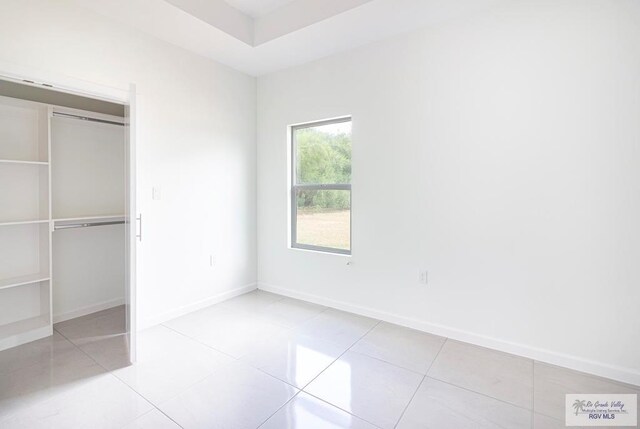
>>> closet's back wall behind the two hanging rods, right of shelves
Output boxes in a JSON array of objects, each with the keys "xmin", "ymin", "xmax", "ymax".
[{"xmin": 51, "ymin": 110, "xmax": 125, "ymax": 323}]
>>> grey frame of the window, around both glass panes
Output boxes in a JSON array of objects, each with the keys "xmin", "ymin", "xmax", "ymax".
[{"xmin": 289, "ymin": 116, "xmax": 353, "ymax": 256}]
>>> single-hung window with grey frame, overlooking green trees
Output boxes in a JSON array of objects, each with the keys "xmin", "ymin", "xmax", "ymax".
[{"xmin": 291, "ymin": 118, "xmax": 351, "ymax": 255}]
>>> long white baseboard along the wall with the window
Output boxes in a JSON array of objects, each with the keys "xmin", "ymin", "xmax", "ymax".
[{"xmin": 258, "ymin": 282, "xmax": 640, "ymax": 386}]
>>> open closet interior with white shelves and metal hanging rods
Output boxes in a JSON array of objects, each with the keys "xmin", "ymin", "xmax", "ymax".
[{"xmin": 0, "ymin": 78, "xmax": 130, "ymax": 350}]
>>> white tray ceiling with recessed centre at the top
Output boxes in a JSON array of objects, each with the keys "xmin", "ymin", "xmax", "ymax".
[{"xmin": 74, "ymin": 0, "xmax": 509, "ymax": 76}]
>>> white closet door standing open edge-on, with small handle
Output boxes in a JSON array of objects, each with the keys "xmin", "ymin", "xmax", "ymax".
[{"xmin": 124, "ymin": 84, "xmax": 137, "ymax": 362}]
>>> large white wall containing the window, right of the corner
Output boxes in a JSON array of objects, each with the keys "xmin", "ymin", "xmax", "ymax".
[{"xmin": 258, "ymin": 0, "xmax": 640, "ymax": 384}]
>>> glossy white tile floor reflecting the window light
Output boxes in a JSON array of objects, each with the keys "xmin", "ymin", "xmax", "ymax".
[{"xmin": 0, "ymin": 291, "xmax": 640, "ymax": 429}]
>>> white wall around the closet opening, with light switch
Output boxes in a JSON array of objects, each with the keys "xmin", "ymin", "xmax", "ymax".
[{"xmin": 0, "ymin": 0, "xmax": 256, "ymax": 327}]
